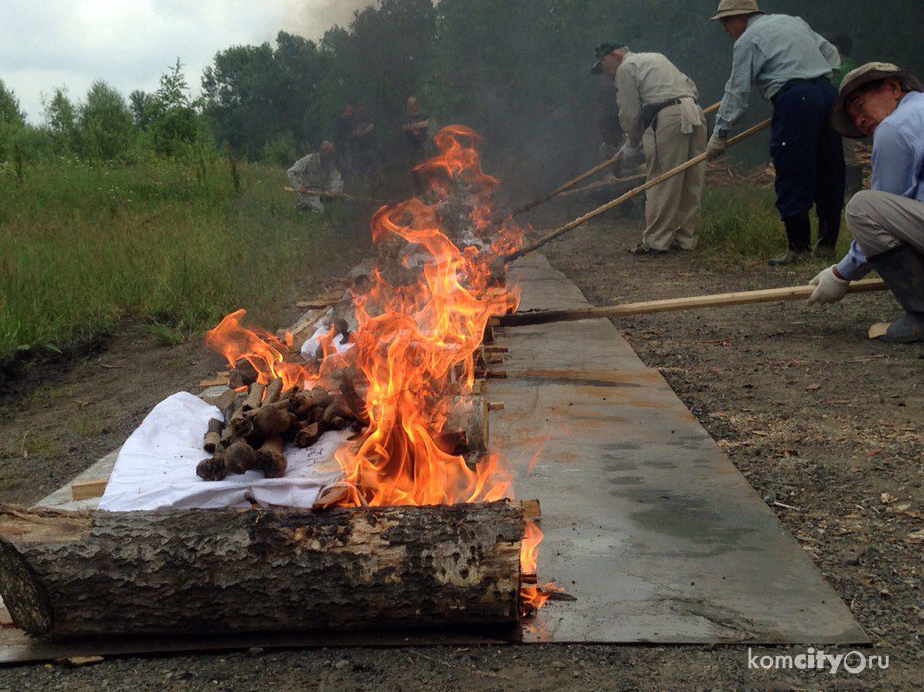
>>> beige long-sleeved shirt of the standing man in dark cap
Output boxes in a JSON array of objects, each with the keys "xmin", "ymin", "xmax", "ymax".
[{"xmin": 616, "ymin": 51, "xmax": 705, "ymax": 145}]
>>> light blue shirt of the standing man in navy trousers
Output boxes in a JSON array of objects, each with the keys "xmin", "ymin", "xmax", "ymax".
[{"xmin": 715, "ymin": 14, "xmax": 841, "ymax": 137}]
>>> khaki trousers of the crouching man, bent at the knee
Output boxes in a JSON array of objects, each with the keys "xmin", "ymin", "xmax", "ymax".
[{"xmin": 846, "ymin": 190, "xmax": 924, "ymax": 257}]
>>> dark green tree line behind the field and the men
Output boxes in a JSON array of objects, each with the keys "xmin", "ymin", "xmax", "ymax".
[{"xmin": 0, "ymin": 0, "xmax": 924, "ymax": 184}]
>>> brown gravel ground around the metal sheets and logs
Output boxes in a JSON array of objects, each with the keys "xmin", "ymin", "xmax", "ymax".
[{"xmin": 0, "ymin": 199, "xmax": 924, "ymax": 692}]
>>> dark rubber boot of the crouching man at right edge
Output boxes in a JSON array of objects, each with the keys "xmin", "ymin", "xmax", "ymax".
[{"xmin": 868, "ymin": 244, "xmax": 924, "ymax": 344}]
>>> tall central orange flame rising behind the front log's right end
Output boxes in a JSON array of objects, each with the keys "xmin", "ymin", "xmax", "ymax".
[{"xmin": 337, "ymin": 126, "xmax": 517, "ymax": 505}]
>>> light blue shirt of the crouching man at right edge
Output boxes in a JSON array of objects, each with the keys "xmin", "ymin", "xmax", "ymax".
[{"xmin": 837, "ymin": 91, "xmax": 924, "ymax": 281}]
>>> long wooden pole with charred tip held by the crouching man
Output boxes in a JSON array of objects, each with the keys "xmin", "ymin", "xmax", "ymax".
[{"xmin": 490, "ymin": 279, "xmax": 888, "ymax": 327}]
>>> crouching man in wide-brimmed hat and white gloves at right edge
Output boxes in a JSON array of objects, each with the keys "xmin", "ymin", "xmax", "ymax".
[{"xmin": 809, "ymin": 62, "xmax": 924, "ymax": 343}]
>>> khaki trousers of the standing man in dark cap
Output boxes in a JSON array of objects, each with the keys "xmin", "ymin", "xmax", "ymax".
[{"xmin": 642, "ymin": 106, "xmax": 706, "ymax": 250}]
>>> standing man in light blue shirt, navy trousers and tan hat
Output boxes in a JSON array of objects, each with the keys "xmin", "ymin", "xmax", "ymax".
[{"xmin": 706, "ymin": 0, "xmax": 844, "ymax": 266}]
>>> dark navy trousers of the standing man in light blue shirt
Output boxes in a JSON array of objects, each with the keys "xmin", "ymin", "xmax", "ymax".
[{"xmin": 770, "ymin": 77, "xmax": 845, "ymax": 221}]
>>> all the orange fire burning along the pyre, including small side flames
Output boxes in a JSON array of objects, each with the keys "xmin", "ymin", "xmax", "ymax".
[{"xmin": 206, "ymin": 126, "xmax": 548, "ymax": 609}]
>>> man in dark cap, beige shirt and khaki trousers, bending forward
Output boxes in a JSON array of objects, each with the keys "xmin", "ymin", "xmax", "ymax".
[{"xmin": 591, "ymin": 43, "xmax": 706, "ymax": 255}]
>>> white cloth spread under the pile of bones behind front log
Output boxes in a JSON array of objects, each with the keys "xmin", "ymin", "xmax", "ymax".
[{"xmin": 99, "ymin": 392, "xmax": 350, "ymax": 512}]
